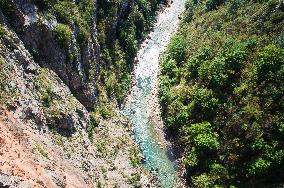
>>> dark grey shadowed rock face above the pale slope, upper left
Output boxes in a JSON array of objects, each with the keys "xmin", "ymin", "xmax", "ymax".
[{"xmin": 2, "ymin": 1, "xmax": 100, "ymax": 108}]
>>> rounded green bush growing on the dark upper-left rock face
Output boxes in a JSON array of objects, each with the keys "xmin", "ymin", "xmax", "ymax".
[{"xmin": 54, "ymin": 24, "xmax": 72, "ymax": 49}]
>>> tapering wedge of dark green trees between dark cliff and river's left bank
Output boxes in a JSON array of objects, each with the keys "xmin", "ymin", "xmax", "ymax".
[{"xmin": 97, "ymin": 0, "xmax": 167, "ymax": 103}]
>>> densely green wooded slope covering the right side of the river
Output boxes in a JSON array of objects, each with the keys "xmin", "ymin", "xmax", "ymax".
[{"xmin": 160, "ymin": 0, "xmax": 284, "ymax": 187}]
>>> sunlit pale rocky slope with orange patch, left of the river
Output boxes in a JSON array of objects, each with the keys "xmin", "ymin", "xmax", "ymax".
[{"xmin": 0, "ymin": 8, "xmax": 153, "ymax": 188}]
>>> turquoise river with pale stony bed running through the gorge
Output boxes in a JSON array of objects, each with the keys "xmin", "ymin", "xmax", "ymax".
[{"xmin": 122, "ymin": 0, "xmax": 186, "ymax": 188}]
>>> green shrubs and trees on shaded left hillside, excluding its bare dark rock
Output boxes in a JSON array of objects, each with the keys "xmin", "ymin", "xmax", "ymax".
[{"xmin": 36, "ymin": 0, "xmax": 166, "ymax": 103}]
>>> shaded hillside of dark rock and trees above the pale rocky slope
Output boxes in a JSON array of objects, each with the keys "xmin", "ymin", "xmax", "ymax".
[{"xmin": 0, "ymin": 0, "xmax": 166, "ymax": 109}]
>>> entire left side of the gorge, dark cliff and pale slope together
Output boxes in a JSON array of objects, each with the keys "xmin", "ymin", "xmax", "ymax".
[{"xmin": 0, "ymin": 0, "xmax": 166, "ymax": 187}]
